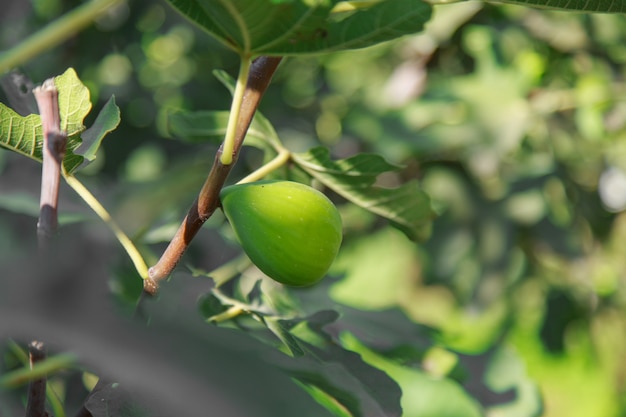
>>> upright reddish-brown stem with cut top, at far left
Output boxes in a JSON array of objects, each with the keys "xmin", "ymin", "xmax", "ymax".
[{"xmin": 33, "ymin": 78, "xmax": 67, "ymax": 248}]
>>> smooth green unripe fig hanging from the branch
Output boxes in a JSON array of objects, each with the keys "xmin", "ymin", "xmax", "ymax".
[{"xmin": 220, "ymin": 180, "xmax": 342, "ymax": 286}]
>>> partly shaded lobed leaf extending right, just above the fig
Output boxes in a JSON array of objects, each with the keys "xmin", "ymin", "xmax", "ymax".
[{"xmin": 293, "ymin": 147, "xmax": 434, "ymax": 240}]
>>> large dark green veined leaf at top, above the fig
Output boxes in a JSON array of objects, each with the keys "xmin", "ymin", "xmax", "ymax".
[{"xmin": 163, "ymin": 0, "xmax": 431, "ymax": 55}]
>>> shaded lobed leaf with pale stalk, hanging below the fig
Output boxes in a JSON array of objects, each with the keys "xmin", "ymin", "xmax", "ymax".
[{"xmin": 199, "ymin": 274, "xmax": 404, "ymax": 417}]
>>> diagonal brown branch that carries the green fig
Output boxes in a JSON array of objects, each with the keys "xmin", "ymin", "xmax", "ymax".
[{"xmin": 144, "ymin": 57, "xmax": 282, "ymax": 295}]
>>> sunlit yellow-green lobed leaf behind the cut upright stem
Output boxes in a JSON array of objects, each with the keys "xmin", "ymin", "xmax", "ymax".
[{"xmin": 0, "ymin": 68, "xmax": 119, "ymax": 173}]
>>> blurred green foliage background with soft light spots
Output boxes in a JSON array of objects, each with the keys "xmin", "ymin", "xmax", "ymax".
[{"xmin": 0, "ymin": 0, "xmax": 626, "ymax": 417}]
